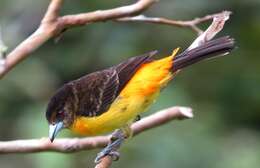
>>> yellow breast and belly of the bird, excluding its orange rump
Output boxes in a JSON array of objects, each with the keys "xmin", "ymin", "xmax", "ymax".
[{"xmin": 71, "ymin": 93, "xmax": 158, "ymax": 136}]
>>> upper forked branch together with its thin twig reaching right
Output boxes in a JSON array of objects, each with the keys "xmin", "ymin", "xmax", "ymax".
[{"xmin": 0, "ymin": 0, "xmax": 230, "ymax": 79}]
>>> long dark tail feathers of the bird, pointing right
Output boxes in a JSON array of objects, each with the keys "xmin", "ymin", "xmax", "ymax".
[{"xmin": 172, "ymin": 36, "xmax": 235, "ymax": 72}]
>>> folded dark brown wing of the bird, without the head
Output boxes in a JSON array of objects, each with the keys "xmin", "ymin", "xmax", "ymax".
[{"xmin": 71, "ymin": 51, "xmax": 157, "ymax": 117}]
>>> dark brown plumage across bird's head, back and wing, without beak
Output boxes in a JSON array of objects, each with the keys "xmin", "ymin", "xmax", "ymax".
[{"xmin": 46, "ymin": 51, "xmax": 157, "ymax": 123}]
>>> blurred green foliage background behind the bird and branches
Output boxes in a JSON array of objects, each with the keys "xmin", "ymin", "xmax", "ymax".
[{"xmin": 0, "ymin": 0, "xmax": 260, "ymax": 168}]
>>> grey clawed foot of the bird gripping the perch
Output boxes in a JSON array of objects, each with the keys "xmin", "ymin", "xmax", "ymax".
[{"xmin": 95, "ymin": 130, "xmax": 125, "ymax": 163}]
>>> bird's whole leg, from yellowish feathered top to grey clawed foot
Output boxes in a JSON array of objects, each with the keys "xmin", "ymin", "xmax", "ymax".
[{"xmin": 95, "ymin": 125, "xmax": 132, "ymax": 163}]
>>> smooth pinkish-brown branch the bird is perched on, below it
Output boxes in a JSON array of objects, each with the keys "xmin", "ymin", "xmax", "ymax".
[{"xmin": 0, "ymin": 107, "xmax": 193, "ymax": 154}]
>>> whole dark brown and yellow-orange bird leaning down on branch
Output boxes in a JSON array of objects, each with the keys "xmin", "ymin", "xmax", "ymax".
[{"xmin": 46, "ymin": 36, "xmax": 235, "ymax": 160}]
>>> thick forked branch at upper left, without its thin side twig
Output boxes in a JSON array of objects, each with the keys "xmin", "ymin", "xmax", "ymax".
[{"xmin": 0, "ymin": 0, "xmax": 156, "ymax": 78}]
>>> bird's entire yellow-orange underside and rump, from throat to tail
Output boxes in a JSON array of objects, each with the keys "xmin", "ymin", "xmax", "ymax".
[{"xmin": 71, "ymin": 49, "xmax": 178, "ymax": 136}]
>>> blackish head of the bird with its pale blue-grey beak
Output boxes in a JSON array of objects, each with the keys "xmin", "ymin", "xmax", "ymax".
[{"xmin": 46, "ymin": 85, "xmax": 75, "ymax": 142}]
